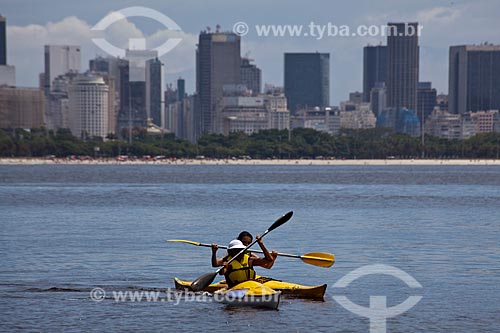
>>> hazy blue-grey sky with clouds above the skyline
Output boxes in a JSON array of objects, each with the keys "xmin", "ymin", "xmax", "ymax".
[{"xmin": 0, "ymin": 0, "xmax": 500, "ymax": 105}]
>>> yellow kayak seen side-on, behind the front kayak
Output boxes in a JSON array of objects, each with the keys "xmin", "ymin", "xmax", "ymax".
[{"xmin": 174, "ymin": 276, "xmax": 327, "ymax": 301}]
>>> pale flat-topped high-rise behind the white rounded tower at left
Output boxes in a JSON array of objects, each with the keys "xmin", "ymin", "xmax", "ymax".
[{"xmin": 44, "ymin": 45, "xmax": 81, "ymax": 95}]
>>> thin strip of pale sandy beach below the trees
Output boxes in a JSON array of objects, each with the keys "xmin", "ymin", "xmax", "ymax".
[{"xmin": 0, "ymin": 158, "xmax": 500, "ymax": 166}]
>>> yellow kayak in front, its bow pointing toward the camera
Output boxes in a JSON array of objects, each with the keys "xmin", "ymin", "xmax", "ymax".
[{"xmin": 213, "ymin": 280, "xmax": 281, "ymax": 310}]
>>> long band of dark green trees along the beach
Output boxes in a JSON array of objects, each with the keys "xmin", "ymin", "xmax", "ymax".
[{"xmin": 0, "ymin": 128, "xmax": 500, "ymax": 159}]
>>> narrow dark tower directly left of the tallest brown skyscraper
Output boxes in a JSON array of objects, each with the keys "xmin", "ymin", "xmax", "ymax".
[{"xmin": 363, "ymin": 45, "xmax": 387, "ymax": 103}]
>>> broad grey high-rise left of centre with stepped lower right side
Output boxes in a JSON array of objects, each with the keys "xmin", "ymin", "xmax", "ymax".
[{"xmin": 196, "ymin": 31, "xmax": 241, "ymax": 134}]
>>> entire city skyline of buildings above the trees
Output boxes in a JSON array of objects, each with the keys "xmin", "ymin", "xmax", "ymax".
[{"xmin": 0, "ymin": 17, "xmax": 500, "ymax": 142}]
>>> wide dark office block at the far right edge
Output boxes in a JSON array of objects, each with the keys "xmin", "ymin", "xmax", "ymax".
[{"xmin": 448, "ymin": 45, "xmax": 500, "ymax": 114}]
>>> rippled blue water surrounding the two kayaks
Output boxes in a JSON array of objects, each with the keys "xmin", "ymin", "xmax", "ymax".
[{"xmin": 0, "ymin": 165, "xmax": 500, "ymax": 332}]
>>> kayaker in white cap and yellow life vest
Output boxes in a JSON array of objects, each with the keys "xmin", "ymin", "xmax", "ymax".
[{"xmin": 212, "ymin": 236, "xmax": 273, "ymax": 288}]
